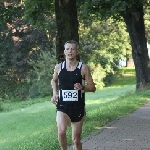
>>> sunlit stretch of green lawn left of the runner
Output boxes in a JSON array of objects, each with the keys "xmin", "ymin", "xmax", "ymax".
[{"xmin": 0, "ymin": 101, "xmax": 58, "ymax": 150}]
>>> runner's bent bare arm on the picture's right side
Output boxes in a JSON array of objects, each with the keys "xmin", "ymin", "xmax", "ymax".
[{"xmin": 82, "ymin": 64, "xmax": 96, "ymax": 92}]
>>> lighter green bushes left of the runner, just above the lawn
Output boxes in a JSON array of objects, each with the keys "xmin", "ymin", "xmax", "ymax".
[{"xmin": 0, "ymin": 51, "xmax": 56, "ymax": 102}]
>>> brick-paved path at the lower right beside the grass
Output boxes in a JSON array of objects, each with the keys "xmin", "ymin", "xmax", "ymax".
[{"xmin": 68, "ymin": 102, "xmax": 150, "ymax": 150}]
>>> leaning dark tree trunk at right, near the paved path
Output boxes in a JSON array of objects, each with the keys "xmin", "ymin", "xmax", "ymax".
[{"xmin": 123, "ymin": 6, "xmax": 149, "ymax": 90}]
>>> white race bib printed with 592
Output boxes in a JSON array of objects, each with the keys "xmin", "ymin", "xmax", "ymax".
[{"xmin": 62, "ymin": 90, "xmax": 78, "ymax": 101}]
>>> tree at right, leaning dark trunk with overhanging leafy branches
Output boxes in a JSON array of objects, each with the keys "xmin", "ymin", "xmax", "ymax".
[{"xmin": 85, "ymin": 0, "xmax": 150, "ymax": 90}]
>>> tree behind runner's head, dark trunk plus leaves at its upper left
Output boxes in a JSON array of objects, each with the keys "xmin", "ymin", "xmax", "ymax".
[{"xmin": 25, "ymin": 0, "xmax": 79, "ymax": 62}]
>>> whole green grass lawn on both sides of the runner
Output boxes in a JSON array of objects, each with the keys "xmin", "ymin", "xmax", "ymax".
[{"xmin": 0, "ymin": 68, "xmax": 150, "ymax": 150}]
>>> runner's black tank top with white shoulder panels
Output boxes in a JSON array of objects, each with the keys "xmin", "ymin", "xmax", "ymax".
[{"xmin": 57, "ymin": 61, "xmax": 85, "ymax": 109}]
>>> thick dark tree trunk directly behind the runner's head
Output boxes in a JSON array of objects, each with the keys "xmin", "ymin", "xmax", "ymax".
[{"xmin": 55, "ymin": 0, "xmax": 79, "ymax": 62}]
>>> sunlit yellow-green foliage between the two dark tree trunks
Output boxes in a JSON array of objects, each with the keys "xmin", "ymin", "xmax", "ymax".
[{"xmin": 79, "ymin": 19, "xmax": 131, "ymax": 87}]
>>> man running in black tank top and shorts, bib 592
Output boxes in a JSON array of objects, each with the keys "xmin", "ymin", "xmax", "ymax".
[{"xmin": 51, "ymin": 40, "xmax": 96, "ymax": 150}]
